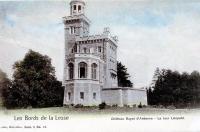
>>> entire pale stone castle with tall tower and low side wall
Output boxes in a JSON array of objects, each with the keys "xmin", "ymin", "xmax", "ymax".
[{"xmin": 63, "ymin": 0, "xmax": 147, "ymax": 106}]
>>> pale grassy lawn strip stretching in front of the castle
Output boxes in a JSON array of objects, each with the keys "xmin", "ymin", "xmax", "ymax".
[{"xmin": 0, "ymin": 107, "xmax": 200, "ymax": 115}]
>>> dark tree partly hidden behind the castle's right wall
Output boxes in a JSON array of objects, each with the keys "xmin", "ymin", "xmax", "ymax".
[{"xmin": 117, "ymin": 62, "xmax": 133, "ymax": 87}]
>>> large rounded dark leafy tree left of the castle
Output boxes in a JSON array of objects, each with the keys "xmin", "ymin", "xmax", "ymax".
[{"xmin": 3, "ymin": 50, "xmax": 64, "ymax": 108}]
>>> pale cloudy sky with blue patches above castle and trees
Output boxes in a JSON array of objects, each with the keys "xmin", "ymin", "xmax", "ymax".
[{"xmin": 0, "ymin": 0, "xmax": 200, "ymax": 87}]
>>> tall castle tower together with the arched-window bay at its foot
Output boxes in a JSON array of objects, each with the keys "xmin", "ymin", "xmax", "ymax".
[{"xmin": 63, "ymin": 0, "xmax": 102, "ymax": 105}]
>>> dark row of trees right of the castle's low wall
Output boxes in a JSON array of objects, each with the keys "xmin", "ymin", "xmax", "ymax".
[{"xmin": 147, "ymin": 68, "xmax": 200, "ymax": 108}]
